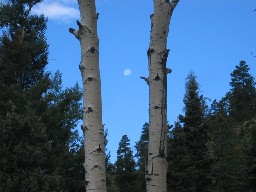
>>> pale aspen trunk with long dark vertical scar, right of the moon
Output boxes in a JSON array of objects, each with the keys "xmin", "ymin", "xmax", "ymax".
[{"xmin": 145, "ymin": 0, "xmax": 179, "ymax": 192}]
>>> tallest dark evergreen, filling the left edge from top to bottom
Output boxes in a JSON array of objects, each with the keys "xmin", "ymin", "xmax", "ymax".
[{"xmin": 0, "ymin": 1, "xmax": 60, "ymax": 191}]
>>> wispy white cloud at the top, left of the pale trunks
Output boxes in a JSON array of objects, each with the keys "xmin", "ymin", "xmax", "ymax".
[{"xmin": 32, "ymin": 0, "xmax": 79, "ymax": 22}]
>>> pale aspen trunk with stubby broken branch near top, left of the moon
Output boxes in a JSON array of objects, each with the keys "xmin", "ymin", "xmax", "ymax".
[{"xmin": 69, "ymin": 0, "xmax": 107, "ymax": 192}]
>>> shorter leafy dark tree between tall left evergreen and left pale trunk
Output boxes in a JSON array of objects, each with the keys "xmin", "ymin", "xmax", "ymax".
[{"xmin": 40, "ymin": 71, "xmax": 84, "ymax": 191}]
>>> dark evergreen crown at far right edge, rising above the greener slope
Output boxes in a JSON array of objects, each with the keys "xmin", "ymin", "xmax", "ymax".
[{"xmin": 229, "ymin": 61, "xmax": 256, "ymax": 122}]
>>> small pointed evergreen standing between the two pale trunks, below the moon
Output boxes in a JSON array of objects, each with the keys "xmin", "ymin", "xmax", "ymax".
[{"xmin": 115, "ymin": 135, "xmax": 136, "ymax": 192}]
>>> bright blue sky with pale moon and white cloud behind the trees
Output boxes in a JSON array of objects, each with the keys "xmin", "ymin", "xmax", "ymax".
[{"xmin": 33, "ymin": 0, "xmax": 256, "ymax": 162}]
